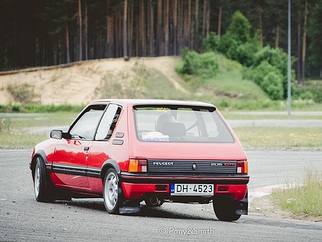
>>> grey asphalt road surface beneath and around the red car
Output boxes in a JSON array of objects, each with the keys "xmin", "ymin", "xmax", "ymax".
[{"xmin": 0, "ymin": 150, "xmax": 322, "ymax": 241}]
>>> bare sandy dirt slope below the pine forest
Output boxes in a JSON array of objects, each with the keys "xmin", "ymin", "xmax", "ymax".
[{"xmin": 0, "ymin": 57, "xmax": 185, "ymax": 105}]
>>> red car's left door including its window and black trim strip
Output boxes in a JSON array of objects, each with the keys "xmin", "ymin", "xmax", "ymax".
[{"xmin": 53, "ymin": 105, "xmax": 106, "ymax": 191}]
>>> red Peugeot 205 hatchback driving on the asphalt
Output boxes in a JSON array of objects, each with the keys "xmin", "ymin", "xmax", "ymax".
[{"xmin": 30, "ymin": 99, "xmax": 249, "ymax": 221}]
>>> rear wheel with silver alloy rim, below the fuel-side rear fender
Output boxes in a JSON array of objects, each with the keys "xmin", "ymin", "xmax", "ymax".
[{"xmin": 103, "ymin": 168, "xmax": 123, "ymax": 214}]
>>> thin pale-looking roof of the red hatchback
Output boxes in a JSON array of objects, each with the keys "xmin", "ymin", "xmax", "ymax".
[{"xmin": 89, "ymin": 99, "xmax": 215, "ymax": 107}]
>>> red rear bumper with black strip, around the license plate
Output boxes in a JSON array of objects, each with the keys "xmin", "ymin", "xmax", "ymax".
[{"xmin": 121, "ymin": 173, "xmax": 249, "ymax": 200}]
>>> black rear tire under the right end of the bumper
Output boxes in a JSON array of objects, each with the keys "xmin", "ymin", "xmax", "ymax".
[{"xmin": 213, "ymin": 198, "xmax": 241, "ymax": 222}]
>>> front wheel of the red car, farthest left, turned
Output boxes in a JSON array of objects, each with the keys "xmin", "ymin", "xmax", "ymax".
[{"xmin": 33, "ymin": 157, "xmax": 53, "ymax": 202}]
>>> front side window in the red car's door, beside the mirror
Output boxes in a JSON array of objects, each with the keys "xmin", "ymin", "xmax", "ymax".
[{"xmin": 69, "ymin": 105, "xmax": 106, "ymax": 140}]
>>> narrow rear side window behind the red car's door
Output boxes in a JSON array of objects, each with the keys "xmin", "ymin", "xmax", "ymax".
[{"xmin": 95, "ymin": 104, "xmax": 121, "ymax": 140}]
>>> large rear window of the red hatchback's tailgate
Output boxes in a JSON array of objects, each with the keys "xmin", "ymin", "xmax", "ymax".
[{"xmin": 134, "ymin": 106, "xmax": 234, "ymax": 143}]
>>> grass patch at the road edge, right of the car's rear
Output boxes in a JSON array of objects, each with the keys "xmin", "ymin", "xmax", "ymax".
[{"xmin": 272, "ymin": 168, "xmax": 322, "ymax": 216}]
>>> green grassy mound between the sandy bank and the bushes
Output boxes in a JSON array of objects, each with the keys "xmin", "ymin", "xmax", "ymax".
[{"xmin": 182, "ymin": 55, "xmax": 273, "ymax": 110}]
